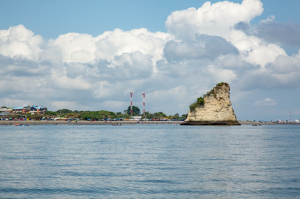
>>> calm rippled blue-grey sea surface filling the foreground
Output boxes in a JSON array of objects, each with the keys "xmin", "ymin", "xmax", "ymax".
[{"xmin": 0, "ymin": 124, "xmax": 300, "ymax": 198}]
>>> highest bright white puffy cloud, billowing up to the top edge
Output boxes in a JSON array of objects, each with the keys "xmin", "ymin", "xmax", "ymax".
[{"xmin": 166, "ymin": 0, "xmax": 263, "ymax": 39}]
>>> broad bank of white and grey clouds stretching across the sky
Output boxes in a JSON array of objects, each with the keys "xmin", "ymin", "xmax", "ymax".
[{"xmin": 0, "ymin": 0, "xmax": 300, "ymax": 118}]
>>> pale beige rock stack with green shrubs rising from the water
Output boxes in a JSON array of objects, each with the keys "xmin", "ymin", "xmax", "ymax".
[{"xmin": 181, "ymin": 83, "xmax": 240, "ymax": 125}]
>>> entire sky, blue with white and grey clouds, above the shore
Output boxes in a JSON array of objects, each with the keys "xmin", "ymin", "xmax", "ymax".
[{"xmin": 0, "ymin": 0, "xmax": 300, "ymax": 121}]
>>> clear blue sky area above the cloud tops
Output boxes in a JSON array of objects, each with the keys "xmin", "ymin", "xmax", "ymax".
[{"xmin": 0, "ymin": 0, "xmax": 300, "ymax": 38}]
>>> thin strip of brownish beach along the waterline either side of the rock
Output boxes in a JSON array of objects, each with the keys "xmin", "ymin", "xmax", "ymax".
[{"xmin": 0, "ymin": 120, "xmax": 300, "ymax": 126}]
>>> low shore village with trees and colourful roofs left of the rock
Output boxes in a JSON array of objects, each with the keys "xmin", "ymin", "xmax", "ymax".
[{"xmin": 0, "ymin": 105, "xmax": 186, "ymax": 121}]
